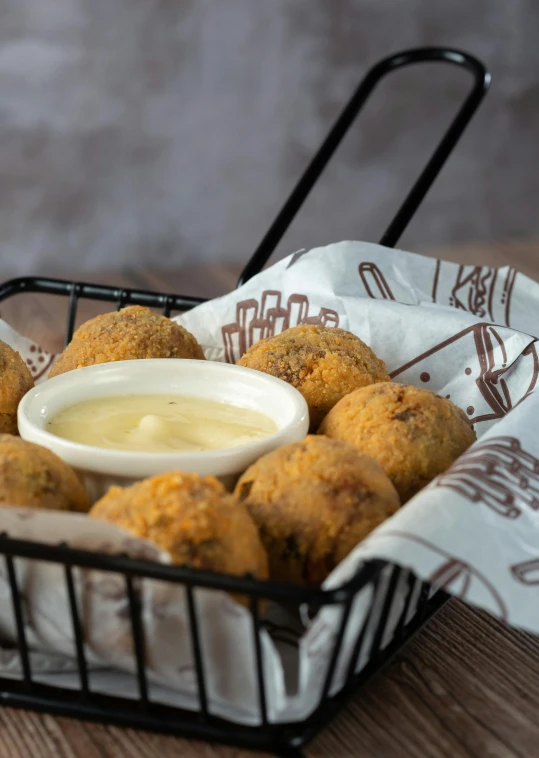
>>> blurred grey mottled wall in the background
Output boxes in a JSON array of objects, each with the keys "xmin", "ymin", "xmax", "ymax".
[{"xmin": 0, "ymin": 0, "xmax": 539, "ymax": 276}]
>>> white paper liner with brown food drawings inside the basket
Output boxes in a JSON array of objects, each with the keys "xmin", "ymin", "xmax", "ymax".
[{"xmin": 0, "ymin": 242, "xmax": 539, "ymax": 723}]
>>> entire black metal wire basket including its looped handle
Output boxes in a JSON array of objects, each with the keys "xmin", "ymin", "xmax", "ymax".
[{"xmin": 0, "ymin": 48, "xmax": 490, "ymax": 755}]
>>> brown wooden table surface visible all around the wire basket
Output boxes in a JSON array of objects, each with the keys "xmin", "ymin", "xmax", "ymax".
[{"xmin": 0, "ymin": 242, "xmax": 539, "ymax": 758}]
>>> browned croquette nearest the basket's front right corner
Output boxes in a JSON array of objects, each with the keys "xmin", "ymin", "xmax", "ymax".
[{"xmin": 234, "ymin": 436, "xmax": 400, "ymax": 586}]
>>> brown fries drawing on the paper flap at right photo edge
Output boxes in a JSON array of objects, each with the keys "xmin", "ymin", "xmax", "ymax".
[{"xmin": 435, "ymin": 437, "xmax": 539, "ymax": 519}]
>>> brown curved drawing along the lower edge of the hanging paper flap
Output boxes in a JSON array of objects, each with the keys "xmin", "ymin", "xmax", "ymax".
[{"xmin": 378, "ymin": 529, "xmax": 508, "ymax": 621}]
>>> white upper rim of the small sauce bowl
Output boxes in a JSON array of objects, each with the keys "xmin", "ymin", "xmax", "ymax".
[{"xmin": 17, "ymin": 358, "xmax": 309, "ymax": 478}]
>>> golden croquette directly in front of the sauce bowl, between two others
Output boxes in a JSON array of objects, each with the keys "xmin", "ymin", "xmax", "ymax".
[{"xmin": 90, "ymin": 472, "xmax": 268, "ymax": 579}]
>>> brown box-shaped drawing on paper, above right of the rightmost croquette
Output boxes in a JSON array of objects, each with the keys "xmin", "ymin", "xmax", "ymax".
[{"xmin": 390, "ymin": 323, "xmax": 539, "ymax": 423}]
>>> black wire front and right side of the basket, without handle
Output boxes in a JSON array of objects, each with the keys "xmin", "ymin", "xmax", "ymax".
[{"xmin": 0, "ymin": 534, "xmax": 447, "ymax": 754}]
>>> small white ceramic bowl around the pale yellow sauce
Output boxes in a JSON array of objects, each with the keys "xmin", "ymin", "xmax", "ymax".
[{"xmin": 18, "ymin": 358, "xmax": 309, "ymax": 500}]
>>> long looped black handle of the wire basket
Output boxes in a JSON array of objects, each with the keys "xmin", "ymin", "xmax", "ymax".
[{"xmin": 237, "ymin": 47, "xmax": 490, "ymax": 287}]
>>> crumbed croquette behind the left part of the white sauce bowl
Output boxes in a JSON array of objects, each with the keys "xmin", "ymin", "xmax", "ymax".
[{"xmin": 49, "ymin": 305, "xmax": 204, "ymax": 377}]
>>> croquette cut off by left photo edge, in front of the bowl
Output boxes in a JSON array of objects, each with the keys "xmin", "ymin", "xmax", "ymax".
[{"xmin": 0, "ymin": 434, "xmax": 90, "ymax": 513}]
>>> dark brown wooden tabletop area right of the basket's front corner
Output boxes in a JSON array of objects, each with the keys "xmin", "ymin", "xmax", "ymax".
[{"xmin": 307, "ymin": 601, "xmax": 539, "ymax": 758}]
